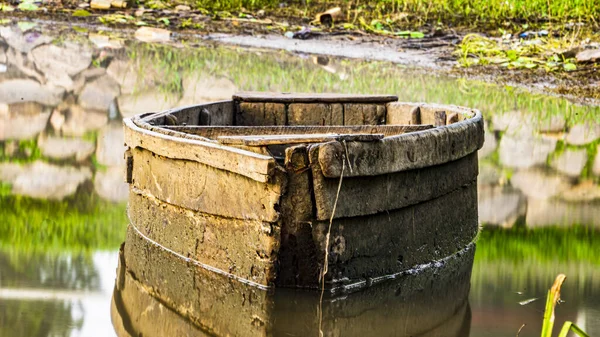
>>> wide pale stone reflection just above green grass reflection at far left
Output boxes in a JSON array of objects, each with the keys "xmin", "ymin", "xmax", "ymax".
[{"xmin": 0, "ymin": 161, "xmax": 92, "ymax": 200}]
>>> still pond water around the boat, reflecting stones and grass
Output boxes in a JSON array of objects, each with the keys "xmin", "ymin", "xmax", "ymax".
[{"xmin": 0, "ymin": 22, "xmax": 600, "ymax": 336}]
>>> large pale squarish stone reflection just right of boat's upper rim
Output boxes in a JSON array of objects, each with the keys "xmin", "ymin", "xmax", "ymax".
[{"xmin": 498, "ymin": 134, "xmax": 557, "ymax": 168}]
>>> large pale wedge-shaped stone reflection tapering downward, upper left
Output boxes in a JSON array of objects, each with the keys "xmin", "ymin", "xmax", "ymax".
[{"xmin": 31, "ymin": 44, "xmax": 92, "ymax": 91}]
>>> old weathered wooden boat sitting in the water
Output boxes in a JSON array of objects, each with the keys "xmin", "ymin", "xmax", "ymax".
[{"xmin": 124, "ymin": 92, "xmax": 484, "ymax": 289}]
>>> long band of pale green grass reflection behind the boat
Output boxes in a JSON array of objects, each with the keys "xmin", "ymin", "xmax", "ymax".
[{"xmin": 128, "ymin": 44, "xmax": 600, "ymax": 125}]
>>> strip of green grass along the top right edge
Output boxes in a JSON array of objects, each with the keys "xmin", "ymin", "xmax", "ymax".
[{"xmin": 183, "ymin": 0, "xmax": 600, "ymax": 25}]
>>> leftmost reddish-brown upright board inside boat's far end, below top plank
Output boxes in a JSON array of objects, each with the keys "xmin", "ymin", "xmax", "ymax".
[{"xmin": 235, "ymin": 102, "xmax": 287, "ymax": 126}]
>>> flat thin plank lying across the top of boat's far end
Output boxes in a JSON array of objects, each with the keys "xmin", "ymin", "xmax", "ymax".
[{"xmin": 233, "ymin": 91, "xmax": 398, "ymax": 103}]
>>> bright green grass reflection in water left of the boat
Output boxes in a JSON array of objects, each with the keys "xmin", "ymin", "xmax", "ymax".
[{"xmin": 0, "ymin": 196, "xmax": 127, "ymax": 251}]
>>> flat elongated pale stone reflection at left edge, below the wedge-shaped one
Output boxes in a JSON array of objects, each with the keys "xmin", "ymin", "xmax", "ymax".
[{"xmin": 0, "ymin": 79, "xmax": 65, "ymax": 106}]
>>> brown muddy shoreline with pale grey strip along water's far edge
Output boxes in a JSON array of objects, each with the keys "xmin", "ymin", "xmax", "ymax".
[{"xmin": 3, "ymin": 11, "xmax": 600, "ymax": 105}]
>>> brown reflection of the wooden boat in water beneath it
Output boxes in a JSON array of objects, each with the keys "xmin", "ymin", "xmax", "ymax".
[{"xmin": 111, "ymin": 226, "xmax": 475, "ymax": 337}]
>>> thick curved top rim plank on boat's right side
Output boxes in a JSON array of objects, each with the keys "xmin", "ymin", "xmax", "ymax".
[{"xmin": 319, "ymin": 111, "xmax": 484, "ymax": 178}]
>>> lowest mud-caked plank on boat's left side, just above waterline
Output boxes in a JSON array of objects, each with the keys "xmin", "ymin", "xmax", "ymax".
[{"xmin": 127, "ymin": 188, "xmax": 280, "ymax": 285}]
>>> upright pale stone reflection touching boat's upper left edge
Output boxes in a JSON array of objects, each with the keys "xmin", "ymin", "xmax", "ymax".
[{"xmin": 96, "ymin": 123, "xmax": 126, "ymax": 168}]
